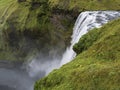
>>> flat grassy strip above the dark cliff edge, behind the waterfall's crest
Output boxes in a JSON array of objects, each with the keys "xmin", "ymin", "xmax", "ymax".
[{"xmin": 49, "ymin": 0, "xmax": 120, "ymax": 11}]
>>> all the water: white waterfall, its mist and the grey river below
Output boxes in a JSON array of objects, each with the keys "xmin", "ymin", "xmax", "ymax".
[{"xmin": 0, "ymin": 11, "xmax": 120, "ymax": 90}]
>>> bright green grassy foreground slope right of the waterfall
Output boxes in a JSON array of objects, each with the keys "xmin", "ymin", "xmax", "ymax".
[{"xmin": 34, "ymin": 19, "xmax": 120, "ymax": 90}]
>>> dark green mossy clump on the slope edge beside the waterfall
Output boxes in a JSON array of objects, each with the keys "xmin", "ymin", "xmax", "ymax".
[{"xmin": 73, "ymin": 29, "xmax": 101, "ymax": 54}]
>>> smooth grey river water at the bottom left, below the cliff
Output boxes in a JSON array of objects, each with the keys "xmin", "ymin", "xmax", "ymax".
[{"xmin": 0, "ymin": 62, "xmax": 35, "ymax": 90}]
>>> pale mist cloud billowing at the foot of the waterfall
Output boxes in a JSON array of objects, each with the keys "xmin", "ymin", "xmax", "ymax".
[{"xmin": 26, "ymin": 56, "xmax": 60, "ymax": 79}]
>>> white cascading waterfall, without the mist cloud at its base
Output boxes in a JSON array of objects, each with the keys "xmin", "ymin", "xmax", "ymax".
[{"xmin": 60, "ymin": 11, "xmax": 120, "ymax": 66}]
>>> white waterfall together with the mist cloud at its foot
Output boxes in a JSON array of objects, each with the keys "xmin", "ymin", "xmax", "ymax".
[{"xmin": 27, "ymin": 11, "xmax": 120, "ymax": 81}]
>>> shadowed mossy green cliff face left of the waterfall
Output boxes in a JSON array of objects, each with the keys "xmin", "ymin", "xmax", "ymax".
[{"xmin": 0, "ymin": 0, "xmax": 75, "ymax": 61}]
